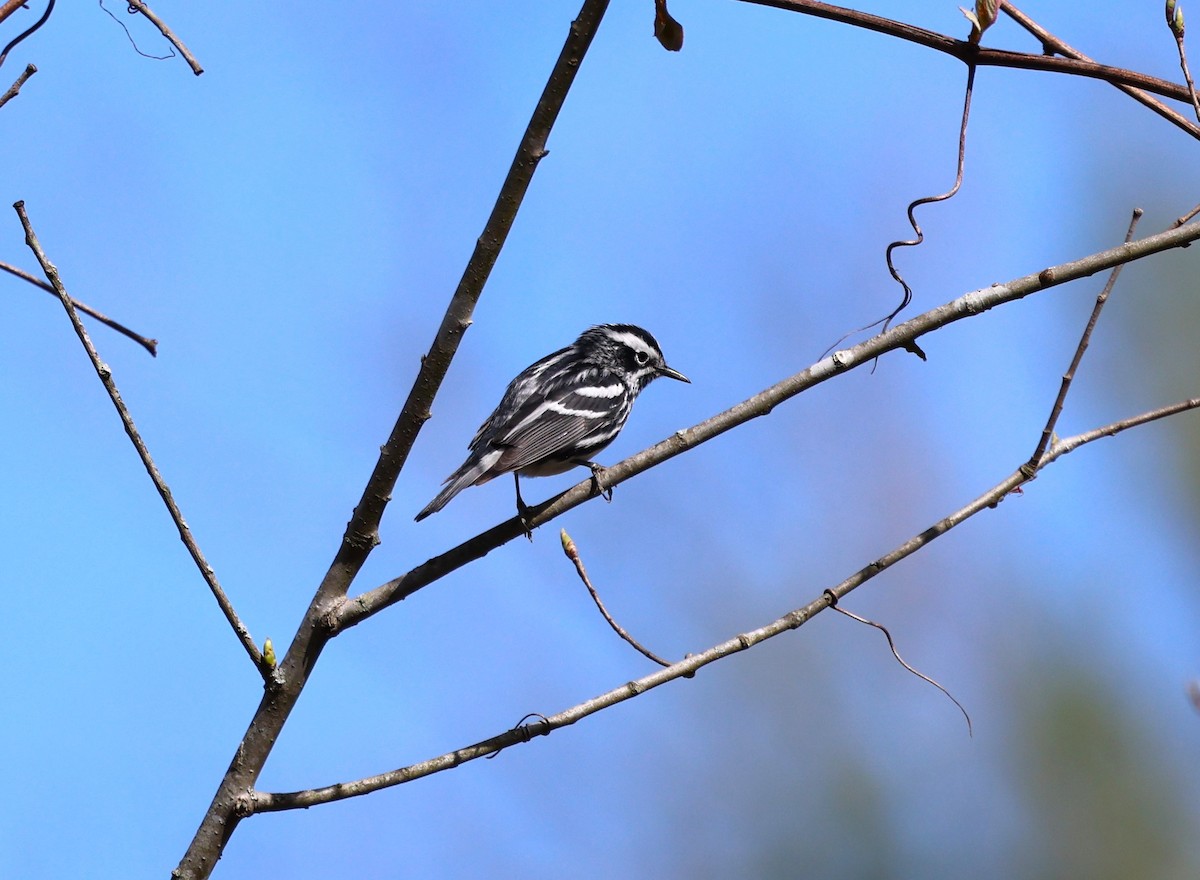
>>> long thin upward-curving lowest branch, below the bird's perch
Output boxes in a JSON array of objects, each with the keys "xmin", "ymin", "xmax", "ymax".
[{"xmin": 246, "ymin": 397, "xmax": 1200, "ymax": 815}]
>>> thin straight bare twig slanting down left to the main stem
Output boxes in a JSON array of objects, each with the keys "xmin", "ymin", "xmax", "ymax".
[{"xmin": 13, "ymin": 202, "xmax": 271, "ymax": 678}]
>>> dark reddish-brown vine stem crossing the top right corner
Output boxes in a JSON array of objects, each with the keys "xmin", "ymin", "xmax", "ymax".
[{"xmin": 740, "ymin": 0, "xmax": 1189, "ymax": 101}]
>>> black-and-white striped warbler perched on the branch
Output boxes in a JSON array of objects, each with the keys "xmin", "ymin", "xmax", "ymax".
[{"xmin": 416, "ymin": 324, "xmax": 690, "ymax": 521}]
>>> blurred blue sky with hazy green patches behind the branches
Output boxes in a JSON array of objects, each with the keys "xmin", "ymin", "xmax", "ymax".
[{"xmin": 0, "ymin": 0, "xmax": 1200, "ymax": 880}]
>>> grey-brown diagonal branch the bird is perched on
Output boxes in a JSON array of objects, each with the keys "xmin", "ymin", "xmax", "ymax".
[{"xmin": 330, "ymin": 223, "xmax": 1200, "ymax": 631}]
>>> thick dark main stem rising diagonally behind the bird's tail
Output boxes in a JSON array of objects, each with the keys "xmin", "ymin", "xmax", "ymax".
[{"xmin": 174, "ymin": 0, "xmax": 608, "ymax": 880}]
